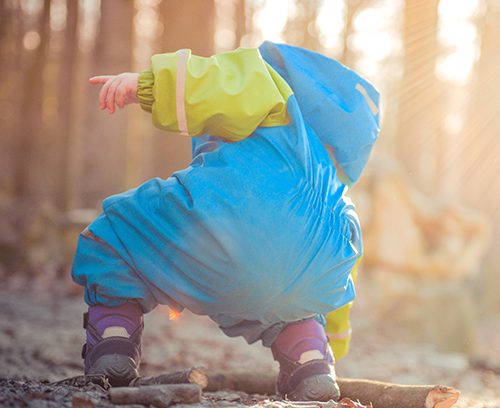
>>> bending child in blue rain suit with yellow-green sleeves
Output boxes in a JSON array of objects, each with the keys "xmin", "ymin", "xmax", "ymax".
[{"xmin": 72, "ymin": 42, "xmax": 379, "ymax": 400}]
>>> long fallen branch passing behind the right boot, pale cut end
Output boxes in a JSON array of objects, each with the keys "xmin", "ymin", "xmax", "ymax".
[{"xmin": 206, "ymin": 372, "xmax": 460, "ymax": 408}]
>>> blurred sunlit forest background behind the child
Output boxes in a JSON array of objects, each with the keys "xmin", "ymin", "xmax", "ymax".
[{"xmin": 0, "ymin": 0, "xmax": 500, "ymax": 353}]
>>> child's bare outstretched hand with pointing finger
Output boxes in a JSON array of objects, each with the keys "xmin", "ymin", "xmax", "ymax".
[{"xmin": 89, "ymin": 72, "xmax": 139, "ymax": 113}]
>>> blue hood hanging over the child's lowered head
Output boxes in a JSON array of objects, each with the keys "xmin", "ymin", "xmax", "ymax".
[{"xmin": 259, "ymin": 41, "xmax": 379, "ymax": 185}]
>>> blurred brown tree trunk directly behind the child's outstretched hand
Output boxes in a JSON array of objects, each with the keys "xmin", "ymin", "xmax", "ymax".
[{"xmin": 82, "ymin": 0, "xmax": 134, "ymax": 207}]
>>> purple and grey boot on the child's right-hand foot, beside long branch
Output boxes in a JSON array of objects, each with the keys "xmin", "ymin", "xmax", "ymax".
[{"xmin": 271, "ymin": 320, "xmax": 340, "ymax": 401}]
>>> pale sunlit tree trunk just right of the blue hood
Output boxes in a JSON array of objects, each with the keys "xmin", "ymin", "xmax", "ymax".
[{"xmin": 397, "ymin": 0, "xmax": 443, "ymax": 193}]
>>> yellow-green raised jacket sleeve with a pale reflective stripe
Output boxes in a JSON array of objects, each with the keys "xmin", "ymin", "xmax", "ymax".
[{"xmin": 137, "ymin": 48, "xmax": 292, "ymax": 141}]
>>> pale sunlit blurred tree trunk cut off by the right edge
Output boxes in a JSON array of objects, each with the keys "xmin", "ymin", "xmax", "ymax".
[{"xmin": 462, "ymin": 0, "xmax": 500, "ymax": 310}]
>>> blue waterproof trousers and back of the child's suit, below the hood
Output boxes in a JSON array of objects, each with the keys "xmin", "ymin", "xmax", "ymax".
[{"xmin": 72, "ymin": 97, "xmax": 361, "ymax": 345}]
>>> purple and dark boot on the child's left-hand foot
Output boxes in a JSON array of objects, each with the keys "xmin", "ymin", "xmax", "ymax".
[{"xmin": 82, "ymin": 303, "xmax": 144, "ymax": 386}]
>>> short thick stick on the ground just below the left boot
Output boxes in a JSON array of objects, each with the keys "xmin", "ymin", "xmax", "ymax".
[{"xmin": 109, "ymin": 384, "xmax": 201, "ymax": 408}]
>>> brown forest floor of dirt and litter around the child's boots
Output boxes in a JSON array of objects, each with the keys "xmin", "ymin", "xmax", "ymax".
[{"xmin": 0, "ymin": 282, "xmax": 500, "ymax": 408}]
